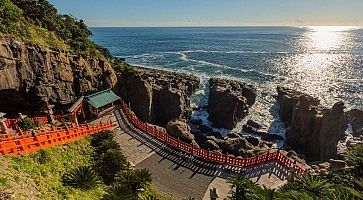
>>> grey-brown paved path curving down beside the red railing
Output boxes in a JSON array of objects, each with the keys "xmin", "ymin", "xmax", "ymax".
[{"xmin": 100, "ymin": 110, "xmax": 287, "ymax": 200}]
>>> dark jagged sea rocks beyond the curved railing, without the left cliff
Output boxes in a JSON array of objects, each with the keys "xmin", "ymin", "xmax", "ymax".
[{"xmin": 115, "ymin": 67, "xmax": 363, "ymax": 171}]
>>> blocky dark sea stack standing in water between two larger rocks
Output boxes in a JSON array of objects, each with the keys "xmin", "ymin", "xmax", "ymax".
[{"xmin": 208, "ymin": 78, "xmax": 256, "ymax": 129}]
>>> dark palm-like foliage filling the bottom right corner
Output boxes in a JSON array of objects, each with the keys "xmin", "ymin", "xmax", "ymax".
[{"xmin": 229, "ymin": 145, "xmax": 363, "ymax": 200}]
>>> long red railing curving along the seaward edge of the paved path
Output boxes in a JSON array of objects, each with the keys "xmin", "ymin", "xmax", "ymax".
[{"xmin": 121, "ymin": 101, "xmax": 304, "ymax": 175}]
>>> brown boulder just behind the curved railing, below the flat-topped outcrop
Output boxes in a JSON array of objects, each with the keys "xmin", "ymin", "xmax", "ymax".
[{"xmin": 166, "ymin": 119, "xmax": 195, "ymax": 144}]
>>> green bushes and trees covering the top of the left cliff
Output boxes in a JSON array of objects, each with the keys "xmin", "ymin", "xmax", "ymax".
[{"xmin": 0, "ymin": 0, "xmax": 111, "ymax": 58}]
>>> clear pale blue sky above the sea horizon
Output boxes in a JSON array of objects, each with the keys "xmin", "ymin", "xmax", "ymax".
[{"xmin": 49, "ymin": 0, "xmax": 363, "ymax": 27}]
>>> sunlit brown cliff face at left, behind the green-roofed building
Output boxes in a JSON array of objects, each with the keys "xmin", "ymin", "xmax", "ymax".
[{"xmin": 0, "ymin": 36, "xmax": 117, "ymax": 112}]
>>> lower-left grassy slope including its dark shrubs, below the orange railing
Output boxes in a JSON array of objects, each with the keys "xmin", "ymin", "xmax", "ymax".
[{"xmin": 0, "ymin": 131, "xmax": 163, "ymax": 200}]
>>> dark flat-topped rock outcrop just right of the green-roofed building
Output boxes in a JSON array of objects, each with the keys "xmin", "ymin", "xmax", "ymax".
[{"xmin": 117, "ymin": 67, "xmax": 200, "ymax": 126}]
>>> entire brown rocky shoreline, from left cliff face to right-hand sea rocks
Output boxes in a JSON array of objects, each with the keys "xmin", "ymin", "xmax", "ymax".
[{"xmin": 0, "ymin": 38, "xmax": 363, "ymax": 170}]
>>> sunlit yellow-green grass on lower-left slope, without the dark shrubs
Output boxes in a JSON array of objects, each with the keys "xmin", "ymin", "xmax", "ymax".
[{"xmin": 0, "ymin": 138, "xmax": 105, "ymax": 200}]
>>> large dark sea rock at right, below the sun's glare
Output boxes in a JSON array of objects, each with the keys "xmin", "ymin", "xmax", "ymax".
[{"xmin": 277, "ymin": 87, "xmax": 348, "ymax": 161}]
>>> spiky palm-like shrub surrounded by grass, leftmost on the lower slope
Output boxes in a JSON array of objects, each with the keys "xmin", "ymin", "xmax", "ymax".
[{"xmin": 63, "ymin": 166, "xmax": 99, "ymax": 190}]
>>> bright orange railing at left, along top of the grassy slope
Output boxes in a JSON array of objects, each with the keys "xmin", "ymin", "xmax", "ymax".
[{"xmin": 0, "ymin": 123, "xmax": 113, "ymax": 156}]
